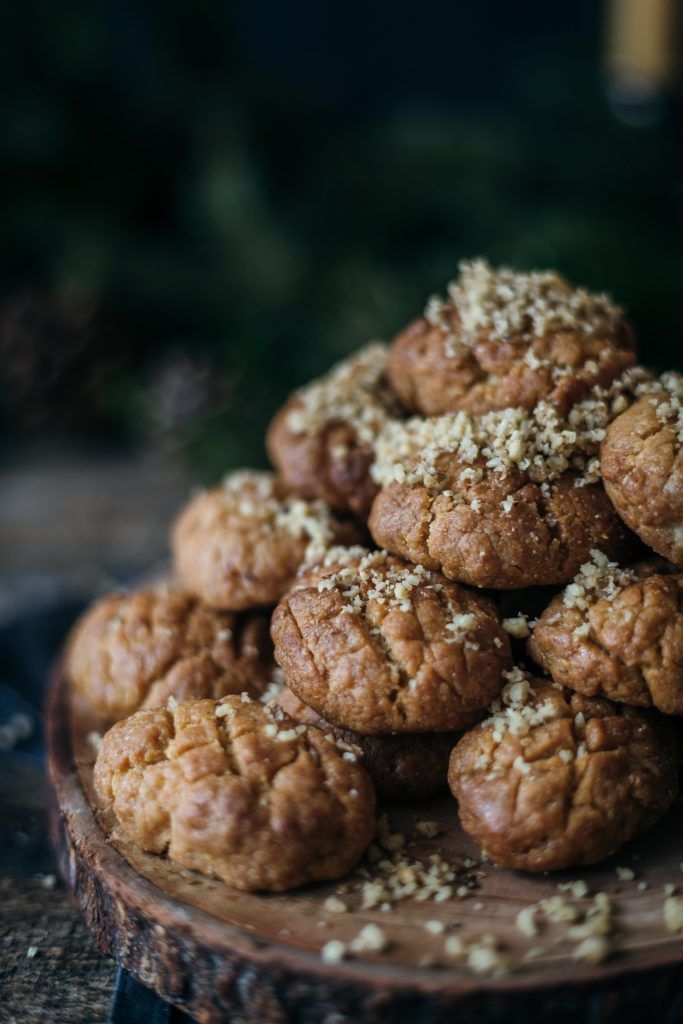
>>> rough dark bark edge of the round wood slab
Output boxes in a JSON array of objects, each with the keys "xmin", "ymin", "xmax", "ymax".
[{"xmin": 46, "ymin": 666, "xmax": 683, "ymax": 1024}]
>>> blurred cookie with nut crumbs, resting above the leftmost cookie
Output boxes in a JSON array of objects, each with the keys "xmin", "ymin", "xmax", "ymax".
[{"xmin": 172, "ymin": 470, "xmax": 359, "ymax": 611}]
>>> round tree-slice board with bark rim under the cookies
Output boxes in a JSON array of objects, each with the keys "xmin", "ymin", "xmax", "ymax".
[{"xmin": 46, "ymin": 671, "xmax": 683, "ymax": 1024}]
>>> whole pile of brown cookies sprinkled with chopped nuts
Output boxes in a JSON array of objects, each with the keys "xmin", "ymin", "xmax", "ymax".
[{"xmin": 68, "ymin": 260, "xmax": 683, "ymax": 891}]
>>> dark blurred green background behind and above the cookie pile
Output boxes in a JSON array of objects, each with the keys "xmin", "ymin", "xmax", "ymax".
[{"xmin": 0, "ymin": 0, "xmax": 683, "ymax": 593}]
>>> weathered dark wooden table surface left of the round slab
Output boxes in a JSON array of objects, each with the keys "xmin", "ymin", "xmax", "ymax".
[{"xmin": 0, "ymin": 451, "xmax": 190, "ymax": 1024}]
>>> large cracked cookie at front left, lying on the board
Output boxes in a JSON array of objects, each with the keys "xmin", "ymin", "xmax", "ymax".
[{"xmin": 94, "ymin": 695, "xmax": 375, "ymax": 892}]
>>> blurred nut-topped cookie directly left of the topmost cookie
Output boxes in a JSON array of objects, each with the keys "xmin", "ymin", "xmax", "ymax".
[{"xmin": 266, "ymin": 343, "xmax": 399, "ymax": 516}]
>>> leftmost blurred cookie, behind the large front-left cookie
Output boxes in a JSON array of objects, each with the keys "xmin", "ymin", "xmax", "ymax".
[{"xmin": 66, "ymin": 586, "xmax": 273, "ymax": 718}]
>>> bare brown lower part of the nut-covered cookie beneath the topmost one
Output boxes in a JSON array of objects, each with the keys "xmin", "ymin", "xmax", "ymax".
[{"xmin": 369, "ymin": 469, "xmax": 631, "ymax": 590}]
